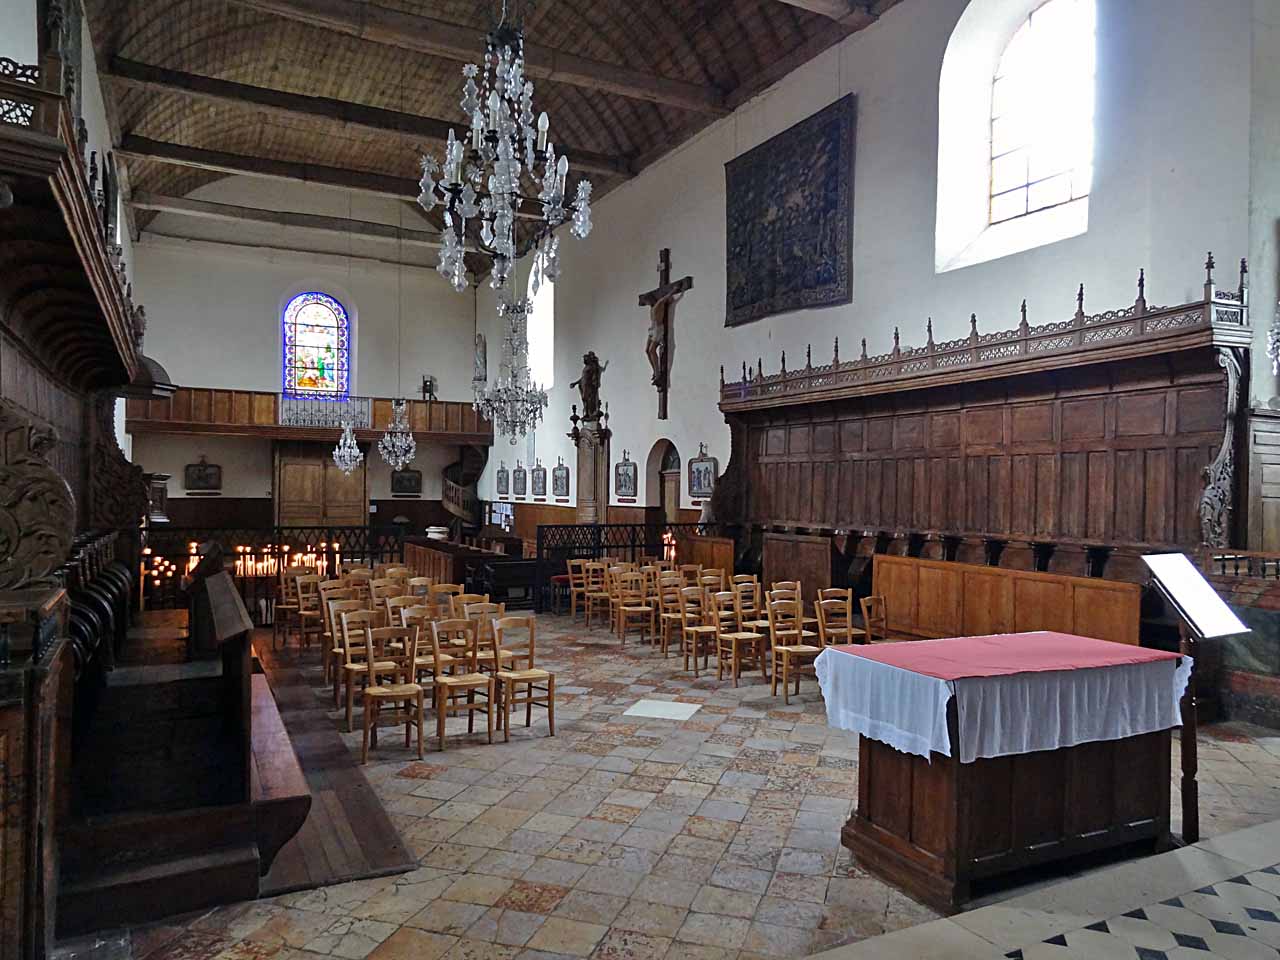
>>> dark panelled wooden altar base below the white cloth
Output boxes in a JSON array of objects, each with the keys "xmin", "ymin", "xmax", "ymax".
[{"xmin": 841, "ymin": 727, "xmax": 1170, "ymax": 914}]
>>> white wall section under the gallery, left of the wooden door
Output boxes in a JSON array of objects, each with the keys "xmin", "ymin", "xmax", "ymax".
[{"xmin": 133, "ymin": 434, "xmax": 271, "ymax": 499}]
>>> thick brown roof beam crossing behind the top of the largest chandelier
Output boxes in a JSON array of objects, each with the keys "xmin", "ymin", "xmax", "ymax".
[{"xmin": 220, "ymin": 0, "xmax": 728, "ymax": 116}]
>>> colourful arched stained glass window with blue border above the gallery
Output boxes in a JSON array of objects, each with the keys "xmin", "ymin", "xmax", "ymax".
[{"xmin": 284, "ymin": 292, "xmax": 351, "ymax": 399}]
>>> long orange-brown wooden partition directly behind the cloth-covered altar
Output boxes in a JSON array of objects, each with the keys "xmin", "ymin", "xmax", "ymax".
[{"xmin": 870, "ymin": 554, "xmax": 1142, "ymax": 644}]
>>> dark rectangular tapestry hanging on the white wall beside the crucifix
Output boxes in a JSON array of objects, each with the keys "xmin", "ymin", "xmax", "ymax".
[{"xmin": 724, "ymin": 93, "xmax": 858, "ymax": 326}]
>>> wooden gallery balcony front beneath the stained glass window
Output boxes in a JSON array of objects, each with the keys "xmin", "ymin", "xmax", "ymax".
[{"xmin": 125, "ymin": 387, "xmax": 493, "ymax": 445}]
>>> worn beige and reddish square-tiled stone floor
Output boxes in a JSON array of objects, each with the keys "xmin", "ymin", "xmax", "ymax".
[{"xmin": 64, "ymin": 616, "xmax": 1280, "ymax": 960}]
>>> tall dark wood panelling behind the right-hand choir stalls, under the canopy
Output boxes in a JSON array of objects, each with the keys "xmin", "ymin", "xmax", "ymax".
[{"xmin": 730, "ymin": 349, "xmax": 1226, "ymax": 547}]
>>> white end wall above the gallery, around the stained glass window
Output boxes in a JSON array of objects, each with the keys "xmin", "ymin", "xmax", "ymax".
[{"xmin": 134, "ymin": 177, "xmax": 475, "ymax": 399}]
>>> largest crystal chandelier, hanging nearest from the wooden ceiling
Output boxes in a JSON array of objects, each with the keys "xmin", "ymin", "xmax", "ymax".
[{"xmin": 417, "ymin": 0, "xmax": 591, "ymax": 293}]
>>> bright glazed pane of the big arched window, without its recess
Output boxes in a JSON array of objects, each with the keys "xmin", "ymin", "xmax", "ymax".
[{"xmin": 989, "ymin": 0, "xmax": 1094, "ymax": 224}]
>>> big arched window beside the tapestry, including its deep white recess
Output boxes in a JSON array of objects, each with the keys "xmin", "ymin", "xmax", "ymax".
[{"xmin": 934, "ymin": 0, "xmax": 1097, "ymax": 273}]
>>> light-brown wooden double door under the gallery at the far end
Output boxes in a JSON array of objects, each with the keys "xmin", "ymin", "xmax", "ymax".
[{"xmin": 275, "ymin": 443, "xmax": 369, "ymax": 526}]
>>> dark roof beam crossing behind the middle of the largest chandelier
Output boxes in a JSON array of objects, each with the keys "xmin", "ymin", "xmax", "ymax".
[{"xmin": 104, "ymin": 58, "xmax": 632, "ymax": 178}]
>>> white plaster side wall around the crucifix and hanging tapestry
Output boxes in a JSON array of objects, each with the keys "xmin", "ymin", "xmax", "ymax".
[{"xmin": 479, "ymin": 0, "xmax": 1254, "ymax": 506}]
